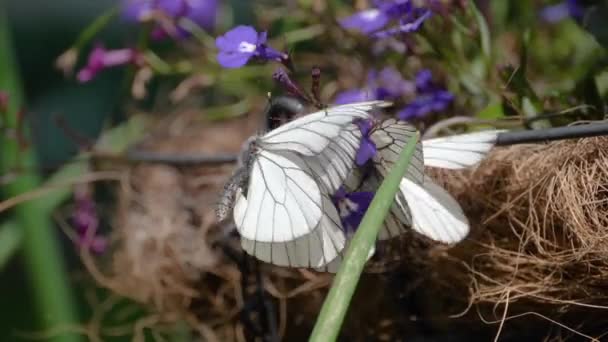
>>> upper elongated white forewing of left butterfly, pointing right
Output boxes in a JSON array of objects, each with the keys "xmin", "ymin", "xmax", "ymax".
[{"xmin": 260, "ymin": 101, "xmax": 390, "ymax": 156}]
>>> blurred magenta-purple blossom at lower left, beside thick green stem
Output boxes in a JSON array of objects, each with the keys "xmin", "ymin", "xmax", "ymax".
[{"xmin": 71, "ymin": 188, "xmax": 107, "ymax": 254}]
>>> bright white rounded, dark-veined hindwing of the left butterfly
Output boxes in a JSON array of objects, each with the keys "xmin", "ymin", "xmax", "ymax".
[{"xmin": 234, "ymin": 150, "xmax": 323, "ymax": 242}]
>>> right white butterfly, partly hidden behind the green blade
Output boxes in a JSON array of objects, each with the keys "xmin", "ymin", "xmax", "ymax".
[{"xmin": 347, "ymin": 119, "xmax": 502, "ymax": 244}]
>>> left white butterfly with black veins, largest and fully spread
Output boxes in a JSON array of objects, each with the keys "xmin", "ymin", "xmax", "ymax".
[{"xmin": 221, "ymin": 101, "xmax": 390, "ymax": 268}]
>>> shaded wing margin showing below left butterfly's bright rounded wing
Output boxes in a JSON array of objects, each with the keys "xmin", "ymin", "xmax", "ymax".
[{"xmin": 241, "ymin": 196, "xmax": 346, "ymax": 270}]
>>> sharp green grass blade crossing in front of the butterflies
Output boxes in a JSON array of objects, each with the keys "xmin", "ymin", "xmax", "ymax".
[{"xmin": 310, "ymin": 135, "xmax": 418, "ymax": 342}]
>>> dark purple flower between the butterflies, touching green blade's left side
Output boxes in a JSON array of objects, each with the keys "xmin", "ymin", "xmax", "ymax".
[{"xmin": 332, "ymin": 187, "xmax": 374, "ymax": 234}]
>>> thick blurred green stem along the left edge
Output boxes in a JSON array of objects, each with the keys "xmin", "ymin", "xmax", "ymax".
[{"xmin": 0, "ymin": 5, "xmax": 80, "ymax": 342}]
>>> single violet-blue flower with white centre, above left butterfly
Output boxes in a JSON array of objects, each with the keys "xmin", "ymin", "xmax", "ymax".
[{"xmin": 215, "ymin": 25, "xmax": 288, "ymax": 68}]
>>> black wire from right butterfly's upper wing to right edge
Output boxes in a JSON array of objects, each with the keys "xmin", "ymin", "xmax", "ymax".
[{"xmin": 496, "ymin": 122, "xmax": 608, "ymax": 146}]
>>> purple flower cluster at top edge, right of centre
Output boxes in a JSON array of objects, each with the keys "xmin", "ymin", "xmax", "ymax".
[{"xmin": 340, "ymin": 0, "xmax": 432, "ymax": 38}]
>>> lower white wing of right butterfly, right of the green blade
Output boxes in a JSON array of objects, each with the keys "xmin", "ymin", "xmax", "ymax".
[{"xmin": 400, "ymin": 178, "xmax": 469, "ymax": 244}]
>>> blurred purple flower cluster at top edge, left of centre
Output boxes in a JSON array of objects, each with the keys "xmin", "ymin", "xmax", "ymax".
[{"xmin": 123, "ymin": 0, "xmax": 218, "ymax": 39}]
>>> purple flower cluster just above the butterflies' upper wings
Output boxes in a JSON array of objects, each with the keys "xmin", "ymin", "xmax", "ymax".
[{"xmin": 334, "ymin": 67, "xmax": 454, "ymax": 120}]
